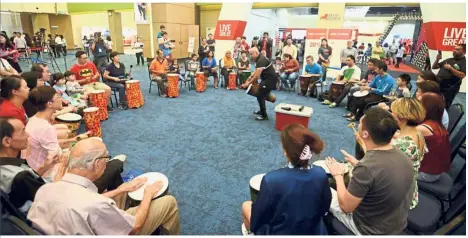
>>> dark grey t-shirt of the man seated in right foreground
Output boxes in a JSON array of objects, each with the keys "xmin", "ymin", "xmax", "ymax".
[{"xmin": 348, "ymin": 148, "xmax": 414, "ymax": 235}]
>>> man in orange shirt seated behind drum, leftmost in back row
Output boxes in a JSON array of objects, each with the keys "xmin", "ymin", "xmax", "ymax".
[{"xmin": 149, "ymin": 50, "xmax": 169, "ymax": 97}]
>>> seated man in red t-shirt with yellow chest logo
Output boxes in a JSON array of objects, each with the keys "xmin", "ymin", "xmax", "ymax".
[{"xmin": 70, "ymin": 50, "xmax": 114, "ymax": 112}]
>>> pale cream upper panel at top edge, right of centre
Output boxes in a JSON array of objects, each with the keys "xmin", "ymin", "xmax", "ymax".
[{"xmin": 317, "ymin": 2, "xmax": 346, "ymax": 29}]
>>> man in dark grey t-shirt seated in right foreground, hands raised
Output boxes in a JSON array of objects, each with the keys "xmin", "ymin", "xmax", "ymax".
[{"xmin": 326, "ymin": 107, "xmax": 414, "ymax": 235}]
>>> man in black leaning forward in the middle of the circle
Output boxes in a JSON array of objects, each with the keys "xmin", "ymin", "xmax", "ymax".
[{"xmin": 242, "ymin": 47, "xmax": 278, "ymax": 121}]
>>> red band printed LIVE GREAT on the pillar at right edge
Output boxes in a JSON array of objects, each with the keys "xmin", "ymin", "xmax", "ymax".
[{"xmin": 421, "ymin": 22, "xmax": 466, "ymax": 51}]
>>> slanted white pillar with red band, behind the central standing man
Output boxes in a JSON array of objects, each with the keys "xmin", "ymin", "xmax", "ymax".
[{"xmin": 214, "ymin": 2, "xmax": 253, "ymax": 60}]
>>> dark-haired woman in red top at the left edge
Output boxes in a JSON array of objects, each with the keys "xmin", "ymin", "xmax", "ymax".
[{"xmin": 0, "ymin": 76, "xmax": 29, "ymax": 125}]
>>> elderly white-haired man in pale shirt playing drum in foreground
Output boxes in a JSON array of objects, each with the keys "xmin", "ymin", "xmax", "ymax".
[{"xmin": 28, "ymin": 138, "xmax": 180, "ymax": 235}]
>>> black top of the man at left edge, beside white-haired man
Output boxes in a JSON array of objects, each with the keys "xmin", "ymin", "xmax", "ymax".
[{"xmin": 0, "ymin": 158, "xmax": 45, "ymax": 208}]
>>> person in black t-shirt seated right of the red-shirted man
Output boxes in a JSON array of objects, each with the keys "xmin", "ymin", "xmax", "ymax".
[{"xmin": 104, "ymin": 51, "xmax": 130, "ymax": 110}]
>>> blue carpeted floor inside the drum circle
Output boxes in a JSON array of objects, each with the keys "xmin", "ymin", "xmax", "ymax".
[{"xmin": 17, "ymin": 52, "xmax": 465, "ymax": 235}]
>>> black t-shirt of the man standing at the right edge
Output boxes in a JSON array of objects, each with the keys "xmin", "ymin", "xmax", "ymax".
[{"xmin": 437, "ymin": 56, "xmax": 466, "ymax": 89}]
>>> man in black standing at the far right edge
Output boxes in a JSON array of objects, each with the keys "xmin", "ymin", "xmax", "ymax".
[{"xmin": 432, "ymin": 44, "xmax": 466, "ymax": 110}]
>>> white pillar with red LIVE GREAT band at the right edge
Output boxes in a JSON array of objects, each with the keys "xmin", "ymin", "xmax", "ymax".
[{"xmin": 420, "ymin": 2, "xmax": 466, "ymax": 92}]
